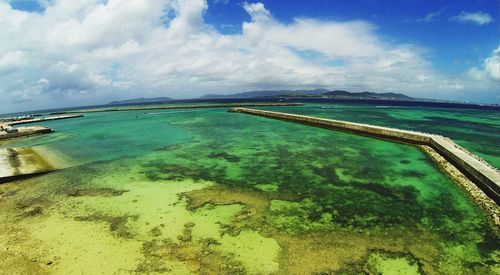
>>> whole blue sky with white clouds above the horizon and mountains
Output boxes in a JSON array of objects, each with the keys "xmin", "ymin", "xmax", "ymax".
[{"xmin": 0, "ymin": 0, "xmax": 500, "ymax": 113}]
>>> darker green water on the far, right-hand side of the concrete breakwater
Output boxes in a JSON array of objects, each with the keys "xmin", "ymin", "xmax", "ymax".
[{"xmin": 263, "ymin": 104, "xmax": 500, "ymax": 168}]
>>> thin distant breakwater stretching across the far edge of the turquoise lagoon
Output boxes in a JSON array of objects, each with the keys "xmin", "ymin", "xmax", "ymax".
[{"xmin": 50, "ymin": 103, "xmax": 304, "ymax": 115}]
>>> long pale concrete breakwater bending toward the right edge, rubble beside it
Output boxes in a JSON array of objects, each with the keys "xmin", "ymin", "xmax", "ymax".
[{"xmin": 230, "ymin": 108, "xmax": 500, "ymax": 205}]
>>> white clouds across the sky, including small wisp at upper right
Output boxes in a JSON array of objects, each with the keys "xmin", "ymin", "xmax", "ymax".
[{"xmin": 0, "ymin": 0, "xmax": 500, "ymax": 113}]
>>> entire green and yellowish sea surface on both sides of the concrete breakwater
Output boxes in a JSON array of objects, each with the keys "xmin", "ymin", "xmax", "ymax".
[{"xmin": 0, "ymin": 102, "xmax": 500, "ymax": 274}]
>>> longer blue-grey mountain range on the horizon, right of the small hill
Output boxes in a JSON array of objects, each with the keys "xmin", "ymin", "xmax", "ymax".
[{"xmin": 200, "ymin": 89, "xmax": 415, "ymax": 100}]
